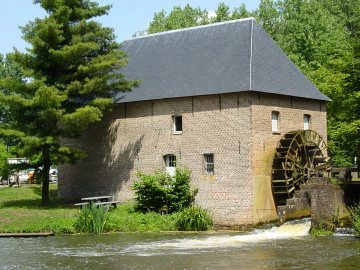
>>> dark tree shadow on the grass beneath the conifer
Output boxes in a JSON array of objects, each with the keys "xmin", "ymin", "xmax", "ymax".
[{"xmin": 0, "ymin": 186, "xmax": 73, "ymax": 210}]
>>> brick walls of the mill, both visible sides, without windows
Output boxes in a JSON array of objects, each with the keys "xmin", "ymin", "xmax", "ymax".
[{"xmin": 59, "ymin": 92, "xmax": 326, "ymax": 225}]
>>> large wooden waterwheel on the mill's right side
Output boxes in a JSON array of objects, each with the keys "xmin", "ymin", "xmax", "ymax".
[{"xmin": 272, "ymin": 130, "xmax": 329, "ymax": 205}]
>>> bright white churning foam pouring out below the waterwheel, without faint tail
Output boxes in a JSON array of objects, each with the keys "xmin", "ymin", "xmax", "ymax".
[{"xmin": 127, "ymin": 219, "xmax": 311, "ymax": 256}]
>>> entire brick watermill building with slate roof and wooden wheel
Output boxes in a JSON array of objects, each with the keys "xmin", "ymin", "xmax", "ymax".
[{"xmin": 59, "ymin": 18, "xmax": 329, "ymax": 225}]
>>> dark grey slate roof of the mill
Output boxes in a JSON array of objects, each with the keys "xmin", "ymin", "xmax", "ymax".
[{"xmin": 115, "ymin": 18, "xmax": 329, "ymax": 103}]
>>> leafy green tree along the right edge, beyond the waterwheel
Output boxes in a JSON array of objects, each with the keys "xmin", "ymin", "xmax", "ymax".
[{"xmin": 319, "ymin": 0, "xmax": 360, "ymax": 165}]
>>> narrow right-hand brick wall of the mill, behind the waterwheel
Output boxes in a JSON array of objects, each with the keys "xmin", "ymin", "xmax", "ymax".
[{"xmin": 251, "ymin": 93, "xmax": 327, "ymax": 223}]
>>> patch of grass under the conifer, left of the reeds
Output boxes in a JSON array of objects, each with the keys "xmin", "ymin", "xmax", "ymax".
[{"xmin": 0, "ymin": 184, "xmax": 78, "ymax": 234}]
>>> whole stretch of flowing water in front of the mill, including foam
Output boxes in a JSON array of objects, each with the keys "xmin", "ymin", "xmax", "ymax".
[{"xmin": 0, "ymin": 220, "xmax": 360, "ymax": 270}]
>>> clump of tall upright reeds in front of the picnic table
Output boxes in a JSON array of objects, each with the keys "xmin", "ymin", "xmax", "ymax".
[{"xmin": 74, "ymin": 204, "xmax": 109, "ymax": 234}]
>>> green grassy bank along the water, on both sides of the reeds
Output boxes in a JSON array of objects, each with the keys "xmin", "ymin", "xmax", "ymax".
[{"xmin": 0, "ymin": 184, "xmax": 176, "ymax": 234}]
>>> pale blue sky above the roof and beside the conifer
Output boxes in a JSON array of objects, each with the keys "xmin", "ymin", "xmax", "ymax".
[{"xmin": 0, "ymin": 0, "xmax": 260, "ymax": 54}]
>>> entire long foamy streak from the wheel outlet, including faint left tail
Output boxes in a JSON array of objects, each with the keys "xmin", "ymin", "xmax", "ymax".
[{"xmin": 43, "ymin": 219, "xmax": 311, "ymax": 258}]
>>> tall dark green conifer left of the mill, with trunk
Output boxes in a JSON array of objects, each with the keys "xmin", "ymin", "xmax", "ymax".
[{"xmin": 0, "ymin": 0, "xmax": 138, "ymax": 204}]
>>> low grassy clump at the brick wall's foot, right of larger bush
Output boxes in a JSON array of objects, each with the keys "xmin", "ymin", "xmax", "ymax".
[{"xmin": 176, "ymin": 206, "xmax": 214, "ymax": 231}]
